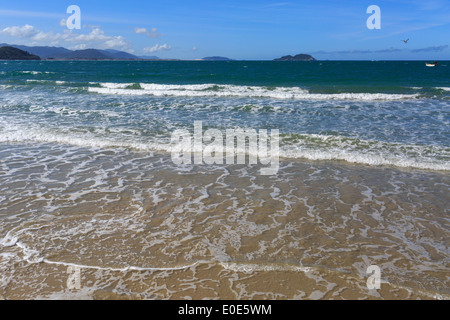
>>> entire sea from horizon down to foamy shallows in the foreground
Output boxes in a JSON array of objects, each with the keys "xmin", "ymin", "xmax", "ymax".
[{"xmin": 0, "ymin": 61, "xmax": 450, "ymax": 300}]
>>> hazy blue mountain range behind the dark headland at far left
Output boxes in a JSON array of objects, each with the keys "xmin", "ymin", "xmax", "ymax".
[{"xmin": 0, "ymin": 44, "xmax": 139, "ymax": 60}]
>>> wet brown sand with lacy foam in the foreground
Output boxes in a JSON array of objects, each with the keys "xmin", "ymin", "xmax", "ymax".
[{"xmin": 0, "ymin": 144, "xmax": 450, "ymax": 299}]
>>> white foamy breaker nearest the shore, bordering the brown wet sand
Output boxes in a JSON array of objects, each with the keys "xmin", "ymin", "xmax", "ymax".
[{"xmin": 0, "ymin": 124, "xmax": 450, "ymax": 171}]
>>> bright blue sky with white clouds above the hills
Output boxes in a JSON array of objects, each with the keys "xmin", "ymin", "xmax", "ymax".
[{"xmin": 0, "ymin": 0, "xmax": 450, "ymax": 60}]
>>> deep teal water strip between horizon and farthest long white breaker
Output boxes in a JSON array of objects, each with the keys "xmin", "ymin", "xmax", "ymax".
[{"xmin": 1, "ymin": 61, "xmax": 450, "ymax": 88}]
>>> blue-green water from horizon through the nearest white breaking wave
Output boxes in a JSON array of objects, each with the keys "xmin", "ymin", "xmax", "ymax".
[{"xmin": 0, "ymin": 61, "xmax": 450, "ymax": 170}]
